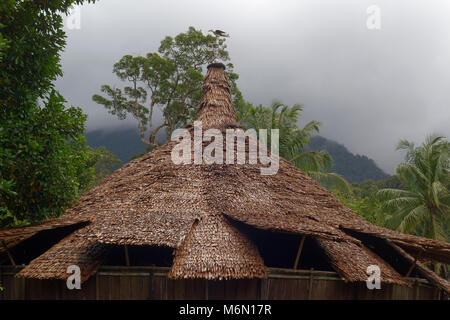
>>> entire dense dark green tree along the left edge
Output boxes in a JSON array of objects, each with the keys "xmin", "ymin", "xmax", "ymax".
[{"xmin": 0, "ymin": 0, "xmax": 97, "ymax": 227}]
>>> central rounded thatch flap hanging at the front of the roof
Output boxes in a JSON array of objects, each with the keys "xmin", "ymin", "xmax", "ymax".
[{"xmin": 169, "ymin": 215, "xmax": 267, "ymax": 280}]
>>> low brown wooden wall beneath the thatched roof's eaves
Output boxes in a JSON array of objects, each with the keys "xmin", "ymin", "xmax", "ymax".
[{"xmin": 0, "ymin": 266, "xmax": 442, "ymax": 300}]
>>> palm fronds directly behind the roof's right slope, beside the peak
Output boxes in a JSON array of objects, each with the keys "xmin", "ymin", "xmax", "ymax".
[{"xmin": 237, "ymin": 101, "xmax": 350, "ymax": 192}]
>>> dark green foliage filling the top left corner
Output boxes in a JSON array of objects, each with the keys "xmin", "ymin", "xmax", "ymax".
[{"xmin": 0, "ymin": 0, "xmax": 94, "ymax": 108}]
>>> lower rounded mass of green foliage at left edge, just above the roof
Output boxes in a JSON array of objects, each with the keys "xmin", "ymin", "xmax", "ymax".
[{"xmin": 0, "ymin": 92, "xmax": 89, "ymax": 228}]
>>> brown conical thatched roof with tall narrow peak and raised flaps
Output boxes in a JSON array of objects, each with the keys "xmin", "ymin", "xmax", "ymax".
[{"xmin": 0, "ymin": 64, "xmax": 450, "ymax": 291}]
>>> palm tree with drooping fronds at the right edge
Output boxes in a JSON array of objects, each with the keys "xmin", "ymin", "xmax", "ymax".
[{"xmin": 377, "ymin": 135, "xmax": 450, "ymax": 241}]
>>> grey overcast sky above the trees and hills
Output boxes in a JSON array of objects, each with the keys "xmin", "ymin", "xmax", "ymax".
[{"xmin": 56, "ymin": 0, "xmax": 450, "ymax": 173}]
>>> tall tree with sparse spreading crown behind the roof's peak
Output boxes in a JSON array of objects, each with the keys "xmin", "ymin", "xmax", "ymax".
[{"xmin": 92, "ymin": 27, "xmax": 240, "ymax": 149}]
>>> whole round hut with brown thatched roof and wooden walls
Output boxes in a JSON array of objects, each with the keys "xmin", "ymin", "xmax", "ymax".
[{"xmin": 0, "ymin": 63, "xmax": 450, "ymax": 299}]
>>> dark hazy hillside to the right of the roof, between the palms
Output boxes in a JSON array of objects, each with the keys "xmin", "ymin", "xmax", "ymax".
[{"xmin": 307, "ymin": 136, "xmax": 389, "ymax": 182}]
